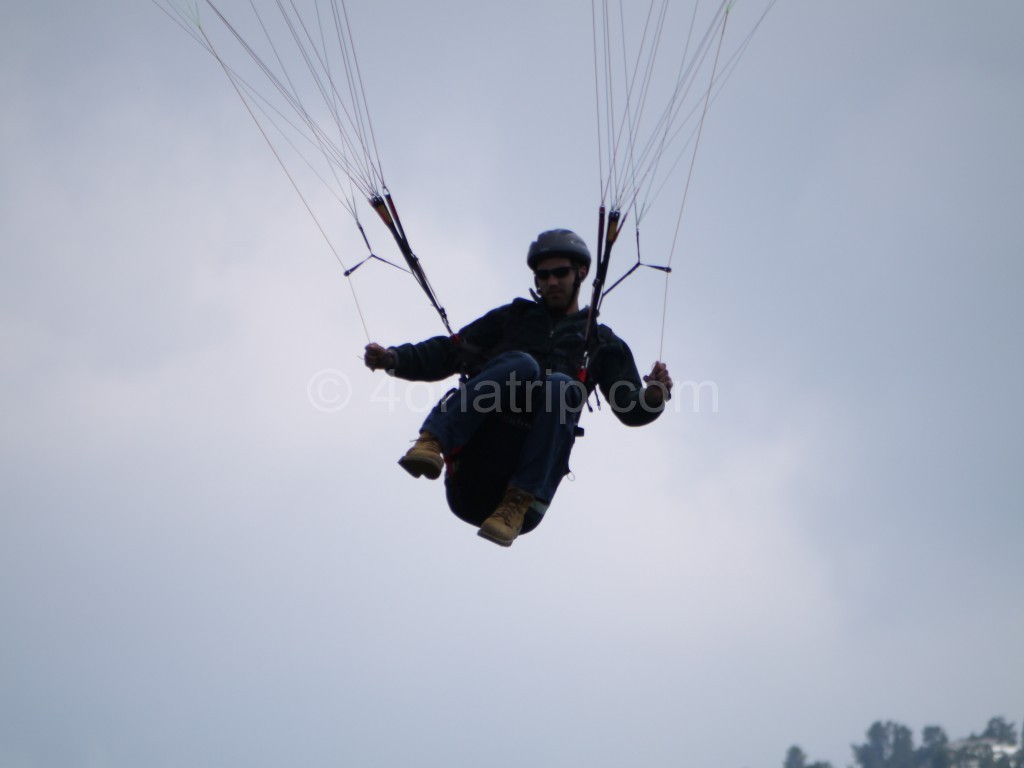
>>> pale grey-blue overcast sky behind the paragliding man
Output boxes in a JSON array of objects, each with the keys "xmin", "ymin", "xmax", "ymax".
[{"xmin": 0, "ymin": 0, "xmax": 1024, "ymax": 768}]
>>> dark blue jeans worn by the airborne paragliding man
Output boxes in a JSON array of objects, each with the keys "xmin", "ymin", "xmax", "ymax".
[{"xmin": 423, "ymin": 352, "xmax": 586, "ymax": 504}]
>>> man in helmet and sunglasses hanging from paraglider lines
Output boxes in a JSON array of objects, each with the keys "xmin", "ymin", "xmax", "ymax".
[{"xmin": 365, "ymin": 229, "xmax": 672, "ymax": 547}]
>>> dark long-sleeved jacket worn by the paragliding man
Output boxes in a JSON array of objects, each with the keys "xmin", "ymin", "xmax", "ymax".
[{"xmin": 392, "ymin": 299, "xmax": 664, "ymax": 427}]
